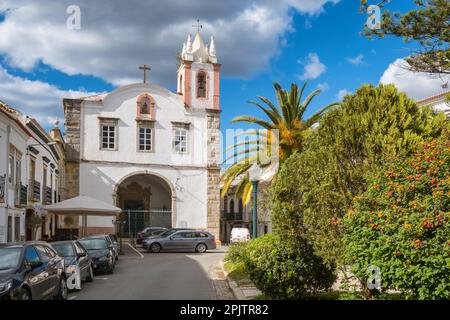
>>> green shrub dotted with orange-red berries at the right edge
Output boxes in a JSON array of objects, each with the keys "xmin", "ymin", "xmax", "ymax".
[{"xmin": 343, "ymin": 134, "xmax": 450, "ymax": 299}]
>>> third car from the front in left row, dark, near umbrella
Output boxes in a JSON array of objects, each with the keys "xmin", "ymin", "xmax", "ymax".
[{"xmin": 79, "ymin": 236, "xmax": 116, "ymax": 274}]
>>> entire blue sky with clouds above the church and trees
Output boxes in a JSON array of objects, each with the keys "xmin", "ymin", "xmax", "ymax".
[{"xmin": 0, "ymin": 0, "xmax": 442, "ymax": 130}]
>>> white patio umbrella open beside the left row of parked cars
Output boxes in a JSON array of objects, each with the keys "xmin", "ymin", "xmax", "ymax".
[{"xmin": 43, "ymin": 196, "xmax": 122, "ymax": 236}]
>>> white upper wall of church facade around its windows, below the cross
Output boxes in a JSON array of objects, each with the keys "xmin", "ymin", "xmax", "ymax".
[{"xmin": 81, "ymin": 84, "xmax": 207, "ymax": 166}]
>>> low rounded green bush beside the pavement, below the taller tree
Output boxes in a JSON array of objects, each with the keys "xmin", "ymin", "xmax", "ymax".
[{"xmin": 241, "ymin": 235, "xmax": 335, "ymax": 299}]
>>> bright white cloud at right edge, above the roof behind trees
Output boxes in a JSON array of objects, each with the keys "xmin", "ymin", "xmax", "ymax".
[{"xmin": 380, "ymin": 59, "xmax": 449, "ymax": 100}]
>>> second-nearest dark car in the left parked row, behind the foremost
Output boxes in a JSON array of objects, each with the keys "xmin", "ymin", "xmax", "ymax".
[{"xmin": 52, "ymin": 241, "xmax": 94, "ymax": 290}]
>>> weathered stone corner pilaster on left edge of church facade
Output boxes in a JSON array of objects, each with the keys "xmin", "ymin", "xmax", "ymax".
[{"xmin": 62, "ymin": 99, "xmax": 82, "ymax": 199}]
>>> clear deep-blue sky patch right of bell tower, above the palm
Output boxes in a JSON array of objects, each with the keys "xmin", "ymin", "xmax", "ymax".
[{"xmin": 222, "ymin": 0, "xmax": 422, "ymax": 132}]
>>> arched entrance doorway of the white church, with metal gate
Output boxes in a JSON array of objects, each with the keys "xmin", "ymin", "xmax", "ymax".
[{"xmin": 115, "ymin": 173, "xmax": 175, "ymax": 237}]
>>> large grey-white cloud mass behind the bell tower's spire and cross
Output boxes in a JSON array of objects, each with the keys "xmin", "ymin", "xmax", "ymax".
[{"xmin": 0, "ymin": 0, "xmax": 338, "ymax": 87}]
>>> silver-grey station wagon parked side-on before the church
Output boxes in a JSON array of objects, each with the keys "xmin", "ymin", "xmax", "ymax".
[{"xmin": 143, "ymin": 229, "xmax": 216, "ymax": 253}]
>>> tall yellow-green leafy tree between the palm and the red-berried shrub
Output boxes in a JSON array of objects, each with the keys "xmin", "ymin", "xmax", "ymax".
[{"xmin": 272, "ymin": 85, "xmax": 445, "ymax": 265}]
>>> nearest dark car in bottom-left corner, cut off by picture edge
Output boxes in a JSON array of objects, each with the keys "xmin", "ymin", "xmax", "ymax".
[{"xmin": 0, "ymin": 242, "xmax": 67, "ymax": 300}]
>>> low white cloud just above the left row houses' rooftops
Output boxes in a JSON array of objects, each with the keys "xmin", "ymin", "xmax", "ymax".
[{"xmin": 0, "ymin": 67, "xmax": 94, "ymax": 126}]
